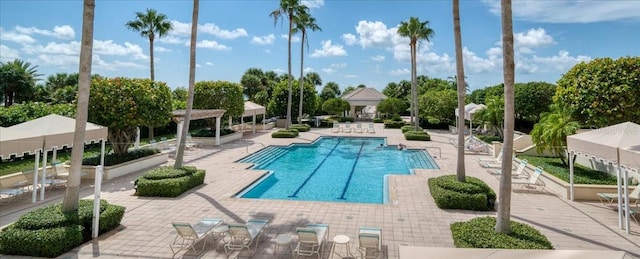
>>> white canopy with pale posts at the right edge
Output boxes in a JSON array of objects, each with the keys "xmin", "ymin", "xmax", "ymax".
[{"xmin": 567, "ymin": 122, "xmax": 640, "ymax": 233}]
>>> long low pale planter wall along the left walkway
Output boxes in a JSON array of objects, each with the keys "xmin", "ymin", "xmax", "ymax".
[{"xmin": 82, "ymin": 153, "xmax": 169, "ymax": 181}]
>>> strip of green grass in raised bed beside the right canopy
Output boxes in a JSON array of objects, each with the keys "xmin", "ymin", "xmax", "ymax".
[{"xmin": 518, "ymin": 156, "xmax": 616, "ymax": 185}]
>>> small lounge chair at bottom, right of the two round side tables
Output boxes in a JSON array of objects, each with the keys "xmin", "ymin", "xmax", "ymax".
[{"xmin": 293, "ymin": 224, "xmax": 329, "ymax": 258}]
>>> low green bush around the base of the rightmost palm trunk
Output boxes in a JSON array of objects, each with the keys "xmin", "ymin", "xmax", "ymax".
[{"xmin": 451, "ymin": 217, "xmax": 553, "ymax": 249}]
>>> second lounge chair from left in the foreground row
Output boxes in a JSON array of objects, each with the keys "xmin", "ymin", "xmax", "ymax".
[{"xmin": 224, "ymin": 219, "xmax": 269, "ymax": 256}]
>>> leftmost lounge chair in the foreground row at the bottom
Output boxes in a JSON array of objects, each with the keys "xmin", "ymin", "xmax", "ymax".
[{"xmin": 169, "ymin": 218, "xmax": 222, "ymax": 257}]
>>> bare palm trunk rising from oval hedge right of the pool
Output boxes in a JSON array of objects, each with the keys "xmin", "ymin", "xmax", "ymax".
[{"xmin": 453, "ymin": 0, "xmax": 466, "ymax": 182}]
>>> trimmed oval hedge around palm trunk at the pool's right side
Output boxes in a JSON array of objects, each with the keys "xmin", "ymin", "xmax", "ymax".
[{"xmin": 428, "ymin": 175, "xmax": 496, "ymax": 211}]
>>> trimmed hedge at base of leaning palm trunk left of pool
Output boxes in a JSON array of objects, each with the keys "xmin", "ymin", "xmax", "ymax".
[{"xmin": 136, "ymin": 166, "xmax": 206, "ymax": 197}]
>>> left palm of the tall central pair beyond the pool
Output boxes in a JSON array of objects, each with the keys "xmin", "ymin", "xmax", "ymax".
[{"xmin": 269, "ymin": 0, "xmax": 309, "ymax": 128}]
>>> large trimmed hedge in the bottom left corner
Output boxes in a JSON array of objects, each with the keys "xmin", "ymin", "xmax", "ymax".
[{"xmin": 0, "ymin": 200, "xmax": 125, "ymax": 257}]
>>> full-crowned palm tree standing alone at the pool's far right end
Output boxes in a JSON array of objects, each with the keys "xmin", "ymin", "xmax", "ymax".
[{"xmin": 398, "ymin": 17, "xmax": 435, "ymax": 130}]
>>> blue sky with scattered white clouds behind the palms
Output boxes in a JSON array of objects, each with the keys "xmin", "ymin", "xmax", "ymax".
[{"xmin": 0, "ymin": 0, "xmax": 640, "ymax": 90}]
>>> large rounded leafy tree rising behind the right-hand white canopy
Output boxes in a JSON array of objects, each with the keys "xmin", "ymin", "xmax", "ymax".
[{"xmin": 554, "ymin": 56, "xmax": 640, "ymax": 128}]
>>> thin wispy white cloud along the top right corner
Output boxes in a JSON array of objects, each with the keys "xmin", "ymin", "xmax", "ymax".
[{"xmin": 482, "ymin": 0, "xmax": 640, "ymax": 23}]
